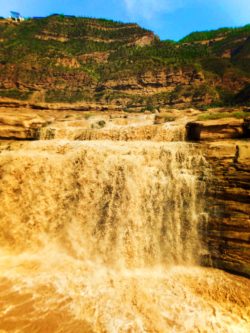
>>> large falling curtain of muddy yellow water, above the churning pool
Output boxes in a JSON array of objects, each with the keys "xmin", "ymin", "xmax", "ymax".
[{"xmin": 0, "ymin": 141, "xmax": 206, "ymax": 267}]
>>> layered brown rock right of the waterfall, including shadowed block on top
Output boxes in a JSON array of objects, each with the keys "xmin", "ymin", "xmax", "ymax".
[{"xmin": 186, "ymin": 118, "xmax": 250, "ymax": 276}]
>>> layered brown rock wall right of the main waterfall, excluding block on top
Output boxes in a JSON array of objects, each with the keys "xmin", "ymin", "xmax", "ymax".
[{"xmin": 206, "ymin": 140, "xmax": 250, "ymax": 277}]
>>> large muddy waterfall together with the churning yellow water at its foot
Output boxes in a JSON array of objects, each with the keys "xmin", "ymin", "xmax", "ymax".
[{"xmin": 0, "ymin": 140, "xmax": 250, "ymax": 333}]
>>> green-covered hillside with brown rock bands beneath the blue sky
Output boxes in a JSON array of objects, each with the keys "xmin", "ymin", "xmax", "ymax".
[{"xmin": 0, "ymin": 15, "xmax": 250, "ymax": 111}]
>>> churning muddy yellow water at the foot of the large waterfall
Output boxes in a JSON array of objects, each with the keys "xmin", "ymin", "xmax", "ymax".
[{"xmin": 0, "ymin": 254, "xmax": 250, "ymax": 333}]
